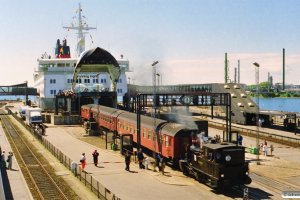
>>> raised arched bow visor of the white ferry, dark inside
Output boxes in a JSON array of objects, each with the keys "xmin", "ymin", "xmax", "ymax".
[{"xmin": 72, "ymin": 47, "xmax": 121, "ymax": 91}]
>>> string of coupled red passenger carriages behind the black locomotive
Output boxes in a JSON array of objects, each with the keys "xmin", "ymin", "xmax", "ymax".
[{"xmin": 81, "ymin": 104, "xmax": 192, "ymax": 162}]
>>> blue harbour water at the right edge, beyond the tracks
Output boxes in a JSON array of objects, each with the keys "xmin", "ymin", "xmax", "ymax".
[{"xmin": 253, "ymin": 98, "xmax": 300, "ymax": 113}]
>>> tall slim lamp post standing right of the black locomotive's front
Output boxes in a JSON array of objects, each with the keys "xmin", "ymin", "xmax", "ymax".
[{"xmin": 253, "ymin": 62, "xmax": 260, "ymax": 165}]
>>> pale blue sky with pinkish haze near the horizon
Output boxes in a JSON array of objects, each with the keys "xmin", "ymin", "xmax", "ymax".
[{"xmin": 0, "ymin": 0, "xmax": 300, "ymax": 86}]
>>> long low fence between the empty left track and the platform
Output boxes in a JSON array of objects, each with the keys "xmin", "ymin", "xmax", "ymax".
[{"xmin": 8, "ymin": 109, "xmax": 121, "ymax": 200}]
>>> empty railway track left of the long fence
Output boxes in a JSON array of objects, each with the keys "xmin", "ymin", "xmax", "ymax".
[{"xmin": 1, "ymin": 115, "xmax": 68, "ymax": 200}]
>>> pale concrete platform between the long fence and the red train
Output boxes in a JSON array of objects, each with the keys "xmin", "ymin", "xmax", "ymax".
[{"xmin": 45, "ymin": 127, "xmax": 226, "ymax": 200}]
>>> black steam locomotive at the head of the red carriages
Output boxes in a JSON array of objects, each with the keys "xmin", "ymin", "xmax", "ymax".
[{"xmin": 179, "ymin": 136, "xmax": 251, "ymax": 189}]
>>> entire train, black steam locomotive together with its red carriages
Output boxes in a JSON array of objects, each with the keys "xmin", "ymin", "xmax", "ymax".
[{"xmin": 81, "ymin": 104, "xmax": 251, "ymax": 188}]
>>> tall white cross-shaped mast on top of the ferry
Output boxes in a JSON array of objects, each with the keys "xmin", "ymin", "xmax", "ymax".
[{"xmin": 63, "ymin": 3, "xmax": 96, "ymax": 57}]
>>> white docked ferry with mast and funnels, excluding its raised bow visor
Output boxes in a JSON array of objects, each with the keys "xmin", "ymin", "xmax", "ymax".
[{"xmin": 33, "ymin": 4, "xmax": 129, "ymax": 110}]
